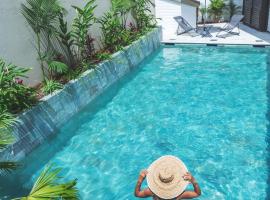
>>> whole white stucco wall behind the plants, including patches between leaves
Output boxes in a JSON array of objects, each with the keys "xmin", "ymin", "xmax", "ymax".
[{"xmin": 0, "ymin": 0, "xmax": 111, "ymax": 85}]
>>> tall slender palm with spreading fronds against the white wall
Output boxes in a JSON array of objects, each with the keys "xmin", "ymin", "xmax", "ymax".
[{"xmin": 21, "ymin": 0, "xmax": 64, "ymax": 79}]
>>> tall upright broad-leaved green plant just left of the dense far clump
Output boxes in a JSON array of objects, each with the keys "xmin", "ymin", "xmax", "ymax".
[{"xmin": 71, "ymin": 0, "xmax": 96, "ymax": 60}]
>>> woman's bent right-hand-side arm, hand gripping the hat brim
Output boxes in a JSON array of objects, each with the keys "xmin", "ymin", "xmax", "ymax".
[{"xmin": 177, "ymin": 173, "xmax": 201, "ymax": 200}]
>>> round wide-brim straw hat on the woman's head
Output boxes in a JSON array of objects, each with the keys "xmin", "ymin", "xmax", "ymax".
[{"xmin": 146, "ymin": 155, "xmax": 189, "ymax": 199}]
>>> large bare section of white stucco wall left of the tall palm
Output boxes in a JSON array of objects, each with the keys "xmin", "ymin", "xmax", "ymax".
[{"xmin": 0, "ymin": 0, "xmax": 40, "ymax": 86}]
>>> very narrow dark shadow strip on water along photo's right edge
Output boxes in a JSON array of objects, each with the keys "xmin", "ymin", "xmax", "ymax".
[{"xmin": 265, "ymin": 52, "xmax": 270, "ymax": 199}]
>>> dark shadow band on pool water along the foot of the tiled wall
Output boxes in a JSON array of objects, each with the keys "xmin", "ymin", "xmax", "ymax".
[{"xmin": 0, "ymin": 50, "xmax": 162, "ymax": 197}]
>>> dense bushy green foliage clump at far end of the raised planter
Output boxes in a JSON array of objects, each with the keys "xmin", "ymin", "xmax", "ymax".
[{"xmin": 98, "ymin": 0, "xmax": 155, "ymax": 53}]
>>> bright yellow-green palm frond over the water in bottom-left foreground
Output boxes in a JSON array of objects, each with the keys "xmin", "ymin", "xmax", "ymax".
[{"xmin": 16, "ymin": 165, "xmax": 79, "ymax": 200}]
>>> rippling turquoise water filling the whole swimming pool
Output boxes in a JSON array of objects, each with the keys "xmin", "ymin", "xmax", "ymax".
[{"xmin": 0, "ymin": 46, "xmax": 270, "ymax": 200}]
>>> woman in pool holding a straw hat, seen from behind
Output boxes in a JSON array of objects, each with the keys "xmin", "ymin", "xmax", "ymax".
[{"xmin": 135, "ymin": 156, "xmax": 201, "ymax": 200}]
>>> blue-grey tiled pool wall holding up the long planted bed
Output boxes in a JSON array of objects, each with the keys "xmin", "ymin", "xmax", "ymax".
[{"xmin": 0, "ymin": 27, "xmax": 161, "ymax": 160}]
